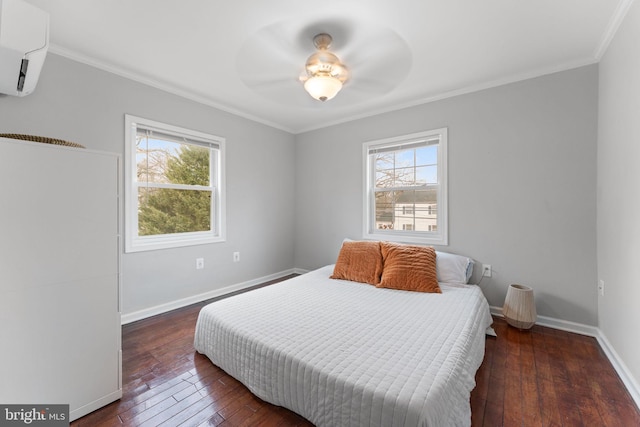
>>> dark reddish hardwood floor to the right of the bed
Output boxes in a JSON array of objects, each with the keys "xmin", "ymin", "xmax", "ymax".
[{"xmin": 471, "ymin": 318, "xmax": 640, "ymax": 427}]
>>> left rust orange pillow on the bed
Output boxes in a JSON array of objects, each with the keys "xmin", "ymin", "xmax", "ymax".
[{"xmin": 331, "ymin": 241, "xmax": 382, "ymax": 285}]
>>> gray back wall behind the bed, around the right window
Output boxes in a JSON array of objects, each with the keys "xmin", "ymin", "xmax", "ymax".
[{"xmin": 295, "ymin": 65, "xmax": 598, "ymax": 325}]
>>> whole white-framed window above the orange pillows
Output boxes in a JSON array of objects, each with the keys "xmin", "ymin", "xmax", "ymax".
[{"xmin": 363, "ymin": 128, "xmax": 448, "ymax": 245}]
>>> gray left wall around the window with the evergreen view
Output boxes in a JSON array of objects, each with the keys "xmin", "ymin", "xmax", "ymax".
[{"xmin": 0, "ymin": 54, "xmax": 294, "ymax": 314}]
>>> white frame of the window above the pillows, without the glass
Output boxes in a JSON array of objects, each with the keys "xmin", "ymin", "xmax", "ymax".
[{"xmin": 362, "ymin": 128, "xmax": 449, "ymax": 246}]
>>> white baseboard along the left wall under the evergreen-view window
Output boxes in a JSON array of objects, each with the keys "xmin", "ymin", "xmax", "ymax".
[{"xmin": 121, "ymin": 268, "xmax": 303, "ymax": 325}]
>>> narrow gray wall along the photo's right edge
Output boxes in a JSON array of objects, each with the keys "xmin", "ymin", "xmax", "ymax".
[{"xmin": 598, "ymin": 2, "xmax": 640, "ymax": 392}]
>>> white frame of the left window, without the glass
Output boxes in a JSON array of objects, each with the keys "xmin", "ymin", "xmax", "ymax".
[{"xmin": 124, "ymin": 114, "xmax": 226, "ymax": 252}]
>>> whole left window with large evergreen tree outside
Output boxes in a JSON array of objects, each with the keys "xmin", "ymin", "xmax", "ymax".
[{"xmin": 125, "ymin": 115, "xmax": 225, "ymax": 252}]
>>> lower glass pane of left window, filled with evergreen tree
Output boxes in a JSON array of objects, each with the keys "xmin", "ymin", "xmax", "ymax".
[{"xmin": 138, "ymin": 188, "xmax": 212, "ymax": 236}]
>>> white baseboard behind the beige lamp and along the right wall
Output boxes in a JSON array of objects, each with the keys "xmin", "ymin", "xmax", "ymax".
[{"xmin": 490, "ymin": 307, "xmax": 640, "ymax": 408}]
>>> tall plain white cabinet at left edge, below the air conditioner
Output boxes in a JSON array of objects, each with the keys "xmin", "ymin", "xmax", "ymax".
[{"xmin": 0, "ymin": 138, "xmax": 122, "ymax": 419}]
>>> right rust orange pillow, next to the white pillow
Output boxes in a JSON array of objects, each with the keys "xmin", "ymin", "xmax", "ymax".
[{"xmin": 376, "ymin": 242, "xmax": 442, "ymax": 294}]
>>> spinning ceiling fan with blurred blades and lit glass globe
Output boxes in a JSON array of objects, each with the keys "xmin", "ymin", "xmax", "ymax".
[{"xmin": 236, "ymin": 18, "xmax": 412, "ymax": 108}]
